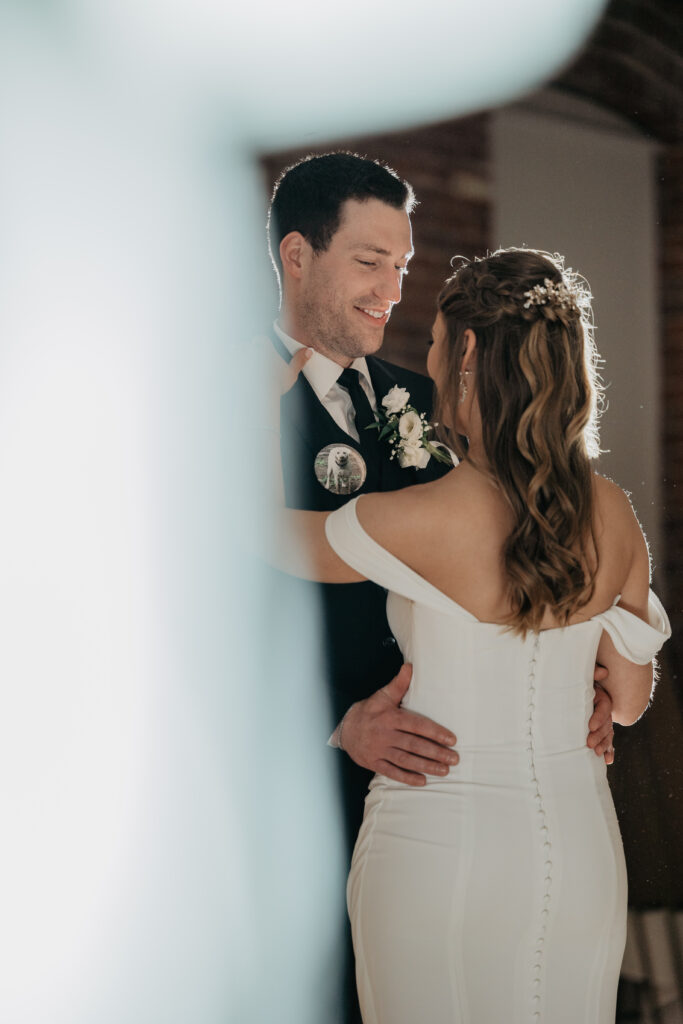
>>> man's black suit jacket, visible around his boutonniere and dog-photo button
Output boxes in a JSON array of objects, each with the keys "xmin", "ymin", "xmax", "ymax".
[{"xmin": 281, "ymin": 356, "xmax": 446, "ymax": 845}]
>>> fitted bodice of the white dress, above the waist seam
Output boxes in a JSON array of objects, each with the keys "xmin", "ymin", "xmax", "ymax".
[{"xmin": 388, "ymin": 593, "xmax": 602, "ymax": 775}]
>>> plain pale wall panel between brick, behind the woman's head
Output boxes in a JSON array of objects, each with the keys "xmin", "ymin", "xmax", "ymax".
[{"xmin": 493, "ymin": 91, "xmax": 661, "ymax": 564}]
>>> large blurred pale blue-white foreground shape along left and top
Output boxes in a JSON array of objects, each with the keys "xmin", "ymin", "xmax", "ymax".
[{"xmin": 0, "ymin": 0, "xmax": 602, "ymax": 1024}]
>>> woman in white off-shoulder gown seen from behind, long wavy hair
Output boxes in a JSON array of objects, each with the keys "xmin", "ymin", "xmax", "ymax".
[{"xmin": 272, "ymin": 249, "xmax": 670, "ymax": 1024}]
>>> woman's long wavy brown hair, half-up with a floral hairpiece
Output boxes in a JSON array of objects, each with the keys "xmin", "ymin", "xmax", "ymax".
[{"xmin": 437, "ymin": 249, "xmax": 601, "ymax": 635}]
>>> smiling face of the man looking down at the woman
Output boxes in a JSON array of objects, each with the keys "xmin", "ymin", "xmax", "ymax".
[{"xmin": 298, "ymin": 199, "xmax": 413, "ymax": 366}]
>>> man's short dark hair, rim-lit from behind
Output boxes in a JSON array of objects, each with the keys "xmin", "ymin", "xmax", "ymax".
[{"xmin": 267, "ymin": 153, "xmax": 416, "ymax": 278}]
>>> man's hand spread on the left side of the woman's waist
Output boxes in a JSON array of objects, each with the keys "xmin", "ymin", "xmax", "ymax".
[{"xmin": 343, "ymin": 665, "xmax": 460, "ymax": 785}]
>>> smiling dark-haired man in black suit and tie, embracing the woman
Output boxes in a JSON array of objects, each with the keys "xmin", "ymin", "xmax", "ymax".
[{"xmin": 268, "ymin": 153, "xmax": 611, "ymax": 1022}]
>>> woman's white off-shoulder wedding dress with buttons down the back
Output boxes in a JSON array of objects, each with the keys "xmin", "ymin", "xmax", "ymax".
[{"xmin": 327, "ymin": 499, "xmax": 670, "ymax": 1024}]
